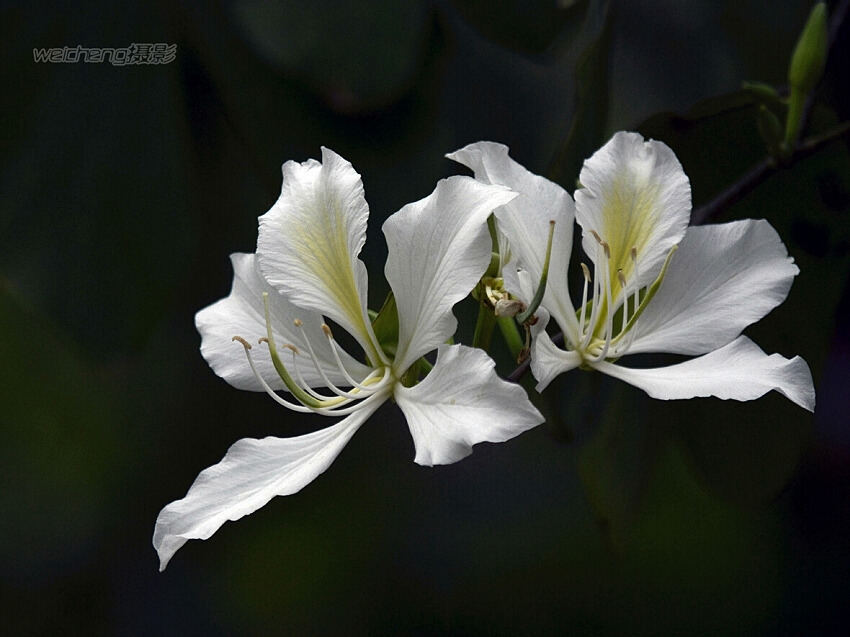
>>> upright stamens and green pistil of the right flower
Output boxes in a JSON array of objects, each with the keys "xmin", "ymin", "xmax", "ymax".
[{"xmin": 571, "ymin": 230, "xmax": 677, "ymax": 363}]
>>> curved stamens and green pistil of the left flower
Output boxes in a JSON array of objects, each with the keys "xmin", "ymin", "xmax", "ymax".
[{"xmin": 233, "ymin": 292, "xmax": 395, "ymax": 416}]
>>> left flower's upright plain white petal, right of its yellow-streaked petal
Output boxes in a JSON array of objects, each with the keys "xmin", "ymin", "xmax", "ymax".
[{"xmin": 384, "ymin": 177, "xmax": 516, "ymax": 373}]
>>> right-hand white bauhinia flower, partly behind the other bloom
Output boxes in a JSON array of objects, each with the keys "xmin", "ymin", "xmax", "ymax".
[{"xmin": 455, "ymin": 132, "xmax": 815, "ymax": 411}]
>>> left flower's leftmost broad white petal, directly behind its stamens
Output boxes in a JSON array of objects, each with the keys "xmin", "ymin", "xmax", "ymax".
[{"xmin": 195, "ymin": 253, "xmax": 371, "ymax": 391}]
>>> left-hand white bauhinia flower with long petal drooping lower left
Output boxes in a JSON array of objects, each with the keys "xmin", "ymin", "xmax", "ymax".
[{"xmin": 153, "ymin": 148, "xmax": 543, "ymax": 570}]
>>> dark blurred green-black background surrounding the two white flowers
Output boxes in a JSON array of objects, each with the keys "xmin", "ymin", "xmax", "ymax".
[{"xmin": 0, "ymin": 0, "xmax": 850, "ymax": 635}]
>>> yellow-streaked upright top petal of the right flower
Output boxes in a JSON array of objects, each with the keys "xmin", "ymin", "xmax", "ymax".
[{"xmin": 575, "ymin": 132, "xmax": 691, "ymax": 294}]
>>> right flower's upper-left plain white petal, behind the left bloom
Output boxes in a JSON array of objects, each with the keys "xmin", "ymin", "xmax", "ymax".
[{"xmin": 446, "ymin": 142, "xmax": 578, "ymax": 332}]
